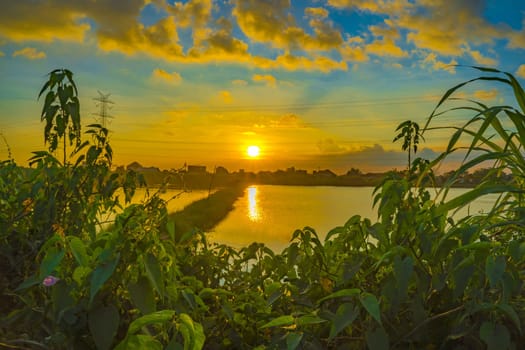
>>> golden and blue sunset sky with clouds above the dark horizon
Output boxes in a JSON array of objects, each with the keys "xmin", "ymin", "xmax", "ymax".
[{"xmin": 0, "ymin": 0, "xmax": 525, "ymax": 173}]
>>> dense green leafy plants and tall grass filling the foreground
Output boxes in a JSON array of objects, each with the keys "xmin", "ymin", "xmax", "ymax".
[{"xmin": 0, "ymin": 69, "xmax": 525, "ymax": 349}]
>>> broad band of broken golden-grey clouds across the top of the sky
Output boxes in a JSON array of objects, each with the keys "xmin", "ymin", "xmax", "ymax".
[{"xmin": 0, "ymin": 0, "xmax": 525, "ymax": 73}]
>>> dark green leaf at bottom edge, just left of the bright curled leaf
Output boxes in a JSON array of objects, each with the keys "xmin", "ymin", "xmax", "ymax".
[{"xmin": 88, "ymin": 305, "xmax": 120, "ymax": 350}]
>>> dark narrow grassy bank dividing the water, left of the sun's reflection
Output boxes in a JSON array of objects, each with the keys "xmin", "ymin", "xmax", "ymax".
[{"xmin": 169, "ymin": 185, "xmax": 244, "ymax": 235}]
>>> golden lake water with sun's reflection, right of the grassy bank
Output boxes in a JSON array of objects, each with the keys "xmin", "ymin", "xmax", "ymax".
[{"xmin": 208, "ymin": 185, "xmax": 497, "ymax": 252}]
